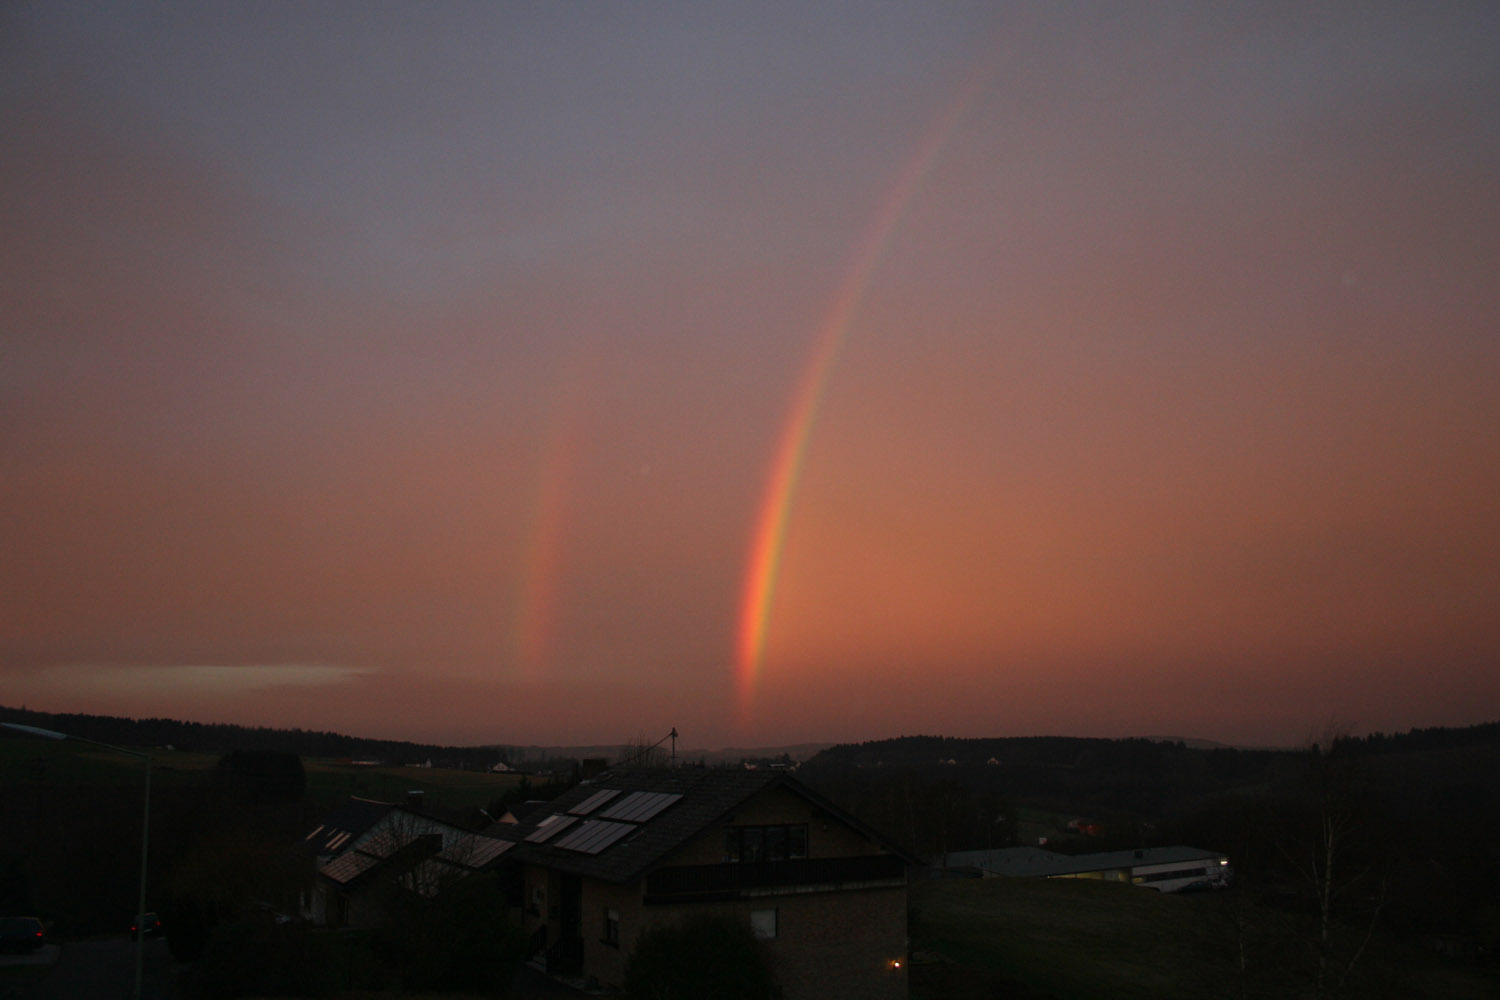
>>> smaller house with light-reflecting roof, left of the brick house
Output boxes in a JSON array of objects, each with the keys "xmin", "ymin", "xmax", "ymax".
[{"xmin": 303, "ymin": 799, "xmax": 515, "ymax": 927}]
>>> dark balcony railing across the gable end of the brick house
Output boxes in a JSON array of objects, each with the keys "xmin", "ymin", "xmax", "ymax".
[{"xmin": 645, "ymin": 855, "xmax": 906, "ymax": 904}]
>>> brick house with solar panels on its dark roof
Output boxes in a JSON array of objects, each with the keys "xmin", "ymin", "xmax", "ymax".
[{"xmin": 504, "ymin": 768, "xmax": 917, "ymax": 1000}]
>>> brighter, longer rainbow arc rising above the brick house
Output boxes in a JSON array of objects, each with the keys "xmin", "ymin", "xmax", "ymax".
[{"xmin": 735, "ymin": 60, "xmax": 990, "ymax": 721}]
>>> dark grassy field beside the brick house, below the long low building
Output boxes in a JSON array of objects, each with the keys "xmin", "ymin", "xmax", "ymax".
[{"xmin": 911, "ymin": 879, "xmax": 1500, "ymax": 1000}]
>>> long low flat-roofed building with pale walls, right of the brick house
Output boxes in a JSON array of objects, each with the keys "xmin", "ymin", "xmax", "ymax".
[{"xmin": 944, "ymin": 847, "xmax": 1235, "ymax": 892}]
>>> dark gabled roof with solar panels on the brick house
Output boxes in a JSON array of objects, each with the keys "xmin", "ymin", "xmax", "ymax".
[{"xmin": 504, "ymin": 768, "xmax": 917, "ymax": 882}]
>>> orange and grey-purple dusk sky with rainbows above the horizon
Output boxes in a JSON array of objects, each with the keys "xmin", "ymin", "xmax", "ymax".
[{"xmin": 0, "ymin": 0, "xmax": 1500, "ymax": 747}]
